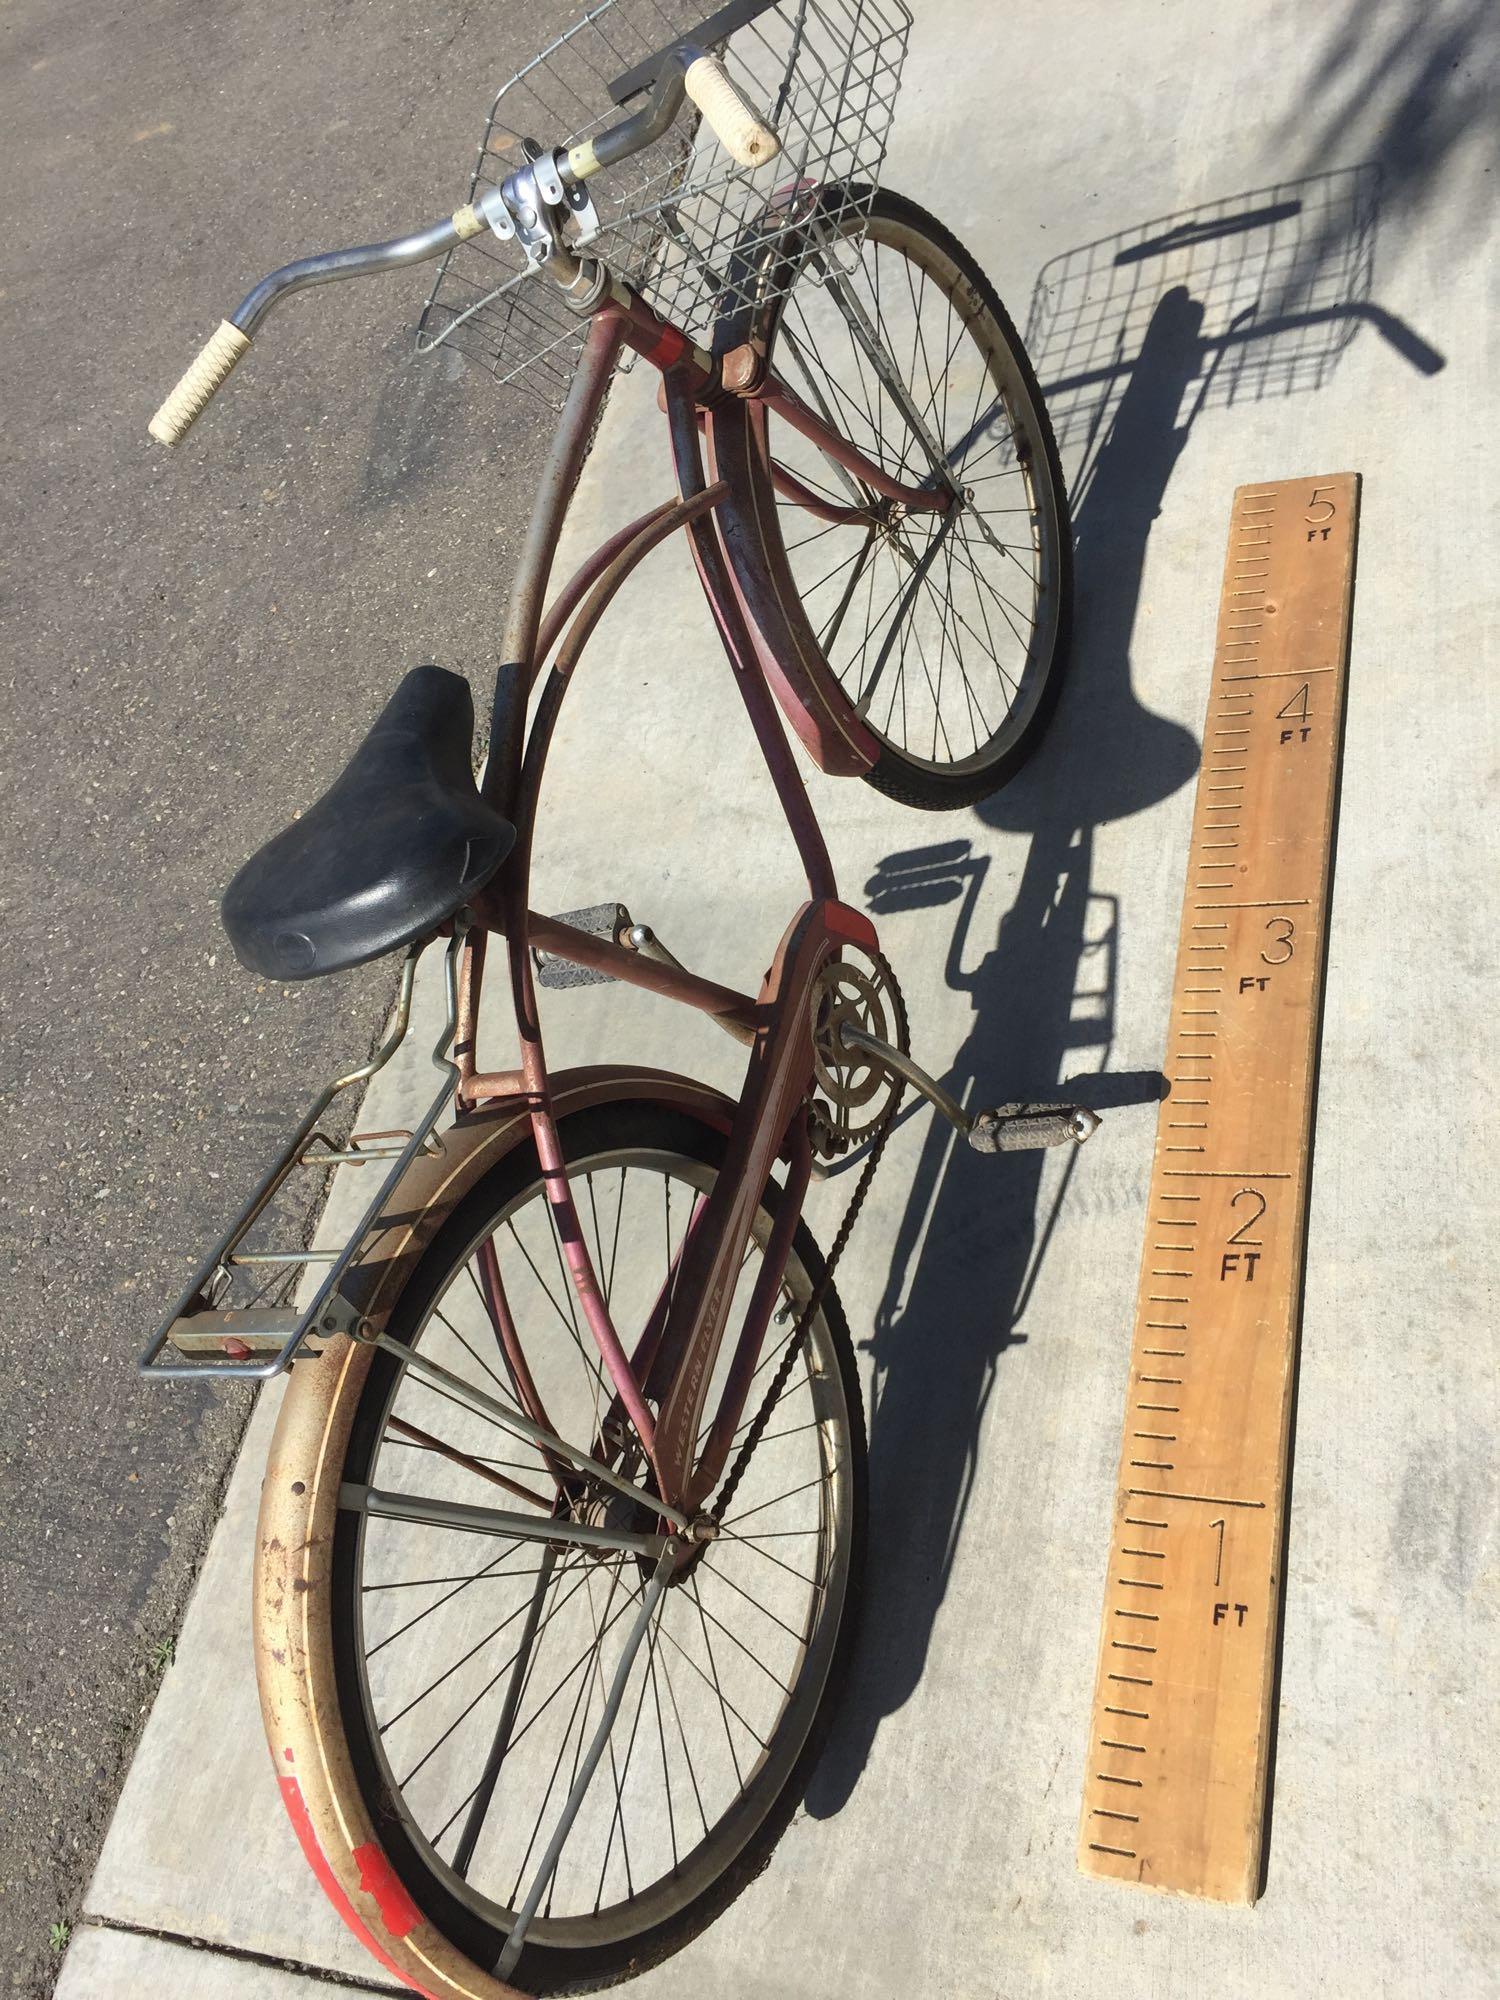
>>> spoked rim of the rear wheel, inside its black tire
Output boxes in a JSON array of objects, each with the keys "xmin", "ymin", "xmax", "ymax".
[{"xmin": 348, "ymin": 1148, "xmax": 852, "ymax": 1950}]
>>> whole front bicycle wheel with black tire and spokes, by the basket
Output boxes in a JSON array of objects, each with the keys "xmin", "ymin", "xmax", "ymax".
[{"xmin": 736, "ymin": 190, "xmax": 1072, "ymax": 810}]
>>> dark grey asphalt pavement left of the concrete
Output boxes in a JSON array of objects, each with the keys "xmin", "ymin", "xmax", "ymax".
[{"xmin": 0, "ymin": 0, "xmax": 580, "ymax": 1994}]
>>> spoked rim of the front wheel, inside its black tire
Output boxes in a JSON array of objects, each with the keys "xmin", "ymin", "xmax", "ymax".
[{"xmin": 768, "ymin": 208, "xmax": 1060, "ymax": 774}]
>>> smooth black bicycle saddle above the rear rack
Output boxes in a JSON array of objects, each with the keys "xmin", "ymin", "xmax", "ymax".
[{"xmin": 222, "ymin": 666, "xmax": 516, "ymax": 980}]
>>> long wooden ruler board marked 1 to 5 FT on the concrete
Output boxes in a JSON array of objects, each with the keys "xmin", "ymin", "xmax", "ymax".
[{"xmin": 1078, "ymin": 472, "xmax": 1358, "ymax": 1902}]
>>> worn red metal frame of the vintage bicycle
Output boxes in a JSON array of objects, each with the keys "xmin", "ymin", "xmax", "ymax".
[{"xmin": 456, "ymin": 286, "xmax": 948, "ymax": 1514}]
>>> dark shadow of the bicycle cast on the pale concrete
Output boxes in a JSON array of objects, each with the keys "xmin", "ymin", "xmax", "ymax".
[{"xmin": 806, "ymin": 170, "xmax": 1442, "ymax": 1818}]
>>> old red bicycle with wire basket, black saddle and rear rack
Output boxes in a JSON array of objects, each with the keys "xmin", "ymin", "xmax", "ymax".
[{"xmin": 142, "ymin": 0, "xmax": 1096, "ymax": 2000}]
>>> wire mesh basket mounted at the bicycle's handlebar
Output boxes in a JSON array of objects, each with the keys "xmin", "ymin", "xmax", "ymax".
[{"xmin": 418, "ymin": 0, "xmax": 912, "ymax": 404}]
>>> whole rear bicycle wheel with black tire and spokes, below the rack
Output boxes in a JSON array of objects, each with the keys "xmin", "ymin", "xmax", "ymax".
[{"xmin": 292, "ymin": 1104, "xmax": 864, "ymax": 1994}]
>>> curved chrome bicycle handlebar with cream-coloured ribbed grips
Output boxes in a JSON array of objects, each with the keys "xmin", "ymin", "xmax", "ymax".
[{"xmin": 148, "ymin": 42, "xmax": 782, "ymax": 444}]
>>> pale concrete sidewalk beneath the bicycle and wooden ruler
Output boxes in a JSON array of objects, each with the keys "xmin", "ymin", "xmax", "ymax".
[{"xmin": 58, "ymin": 0, "xmax": 1500, "ymax": 2000}]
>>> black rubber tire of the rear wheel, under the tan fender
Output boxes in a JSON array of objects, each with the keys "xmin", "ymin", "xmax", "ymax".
[{"xmin": 310, "ymin": 1102, "xmax": 866, "ymax": 1994}]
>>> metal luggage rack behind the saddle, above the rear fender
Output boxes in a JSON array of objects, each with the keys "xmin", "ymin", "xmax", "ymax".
[{"xmin": 138, "ymin": 920, "xmax": 468, "ymax": 1382}]
